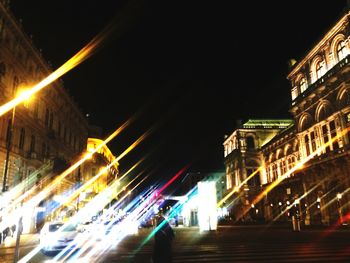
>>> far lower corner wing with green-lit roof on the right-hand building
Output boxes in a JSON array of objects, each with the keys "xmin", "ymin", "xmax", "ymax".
[{"xmin": 224, "ymin": 120, "xmax": 293, "ymax": 221}]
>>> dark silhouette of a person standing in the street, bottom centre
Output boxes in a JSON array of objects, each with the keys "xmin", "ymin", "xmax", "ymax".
[{"xmin": 153, "ymin": 216, "xmax": 175, "ymax": 263}]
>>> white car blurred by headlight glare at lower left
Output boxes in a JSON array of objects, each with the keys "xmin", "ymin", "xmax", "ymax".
[{"xmin": 40, "ymin": 222, "xmax": 79, "ymax": 255}]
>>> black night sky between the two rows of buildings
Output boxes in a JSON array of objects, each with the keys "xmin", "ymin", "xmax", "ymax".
[{"xmin": 11, "ymin": 0, "xmax": 346, "ymax": 192}]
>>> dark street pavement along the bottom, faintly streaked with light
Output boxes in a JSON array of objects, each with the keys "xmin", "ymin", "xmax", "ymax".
[{"xmin": 0, "ymin": 225, "xmax": 350, "ymax": 263}]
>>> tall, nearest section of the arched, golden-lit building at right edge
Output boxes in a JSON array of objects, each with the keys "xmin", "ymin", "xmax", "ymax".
[{"xmin": 288, "ymin": 6, "xmax": 350, "ymax": 224}]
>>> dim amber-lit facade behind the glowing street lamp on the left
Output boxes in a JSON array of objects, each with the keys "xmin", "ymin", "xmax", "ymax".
[{"xmin": 0, "ymin": 1, "xmax": 88, "ymax": 195}]
